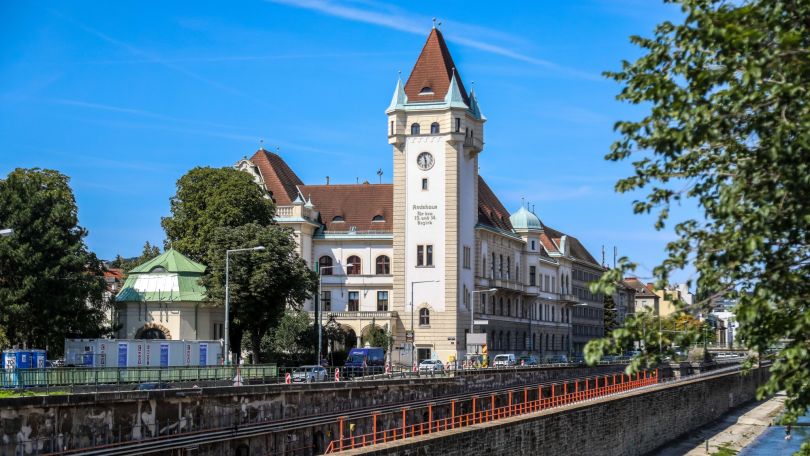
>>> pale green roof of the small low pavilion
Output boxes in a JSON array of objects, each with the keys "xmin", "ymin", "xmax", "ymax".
[{"xmin": 115, "ymin": 249, "xmax": 208, "ymax": 302}]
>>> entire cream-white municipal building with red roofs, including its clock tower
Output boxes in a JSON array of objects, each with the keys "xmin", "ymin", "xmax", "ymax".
[{"xmin": 236, "ymin": 29, "xmax": 604, "ymax": 364}]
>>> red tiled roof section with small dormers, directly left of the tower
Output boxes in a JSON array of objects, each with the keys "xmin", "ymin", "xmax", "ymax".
[{"xmin": 298, "ymin": 184, "xmax": 394, "ymax": 233}]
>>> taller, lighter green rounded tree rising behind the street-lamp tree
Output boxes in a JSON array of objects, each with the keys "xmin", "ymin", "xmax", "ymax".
[{"xmin": 161, "ymin": 167, "xmax": 275, "ymax": 264}]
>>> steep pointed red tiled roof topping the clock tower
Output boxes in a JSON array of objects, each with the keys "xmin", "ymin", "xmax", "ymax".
[{"xmin": 405, "ymin": 29, "xmax": 470, "ymax": 106}]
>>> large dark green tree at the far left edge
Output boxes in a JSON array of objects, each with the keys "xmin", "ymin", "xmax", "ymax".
[{"xmin": 0, "ymin": 168, "xmax": 109, "ymax": 353}]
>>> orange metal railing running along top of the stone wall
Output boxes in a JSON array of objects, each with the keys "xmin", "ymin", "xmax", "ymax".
[{"xmin": 325, "ymin": 369, "xmax": 658, "ymax": 454}]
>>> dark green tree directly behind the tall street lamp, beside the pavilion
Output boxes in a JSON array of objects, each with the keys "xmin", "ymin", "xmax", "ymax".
[{"xmin": 202, "ymin": 223, "xmax": 317, "ymax": 362}]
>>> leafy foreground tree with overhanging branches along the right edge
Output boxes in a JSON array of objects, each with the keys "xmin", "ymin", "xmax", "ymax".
[{"xmin": 586, "ymin": 0, "xmax": 810, "ymax": 436}]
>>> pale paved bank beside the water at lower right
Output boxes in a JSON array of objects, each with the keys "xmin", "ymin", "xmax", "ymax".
[{"xmin": 650, "ymin": 394, "xmax": 785, "ymax": 456}]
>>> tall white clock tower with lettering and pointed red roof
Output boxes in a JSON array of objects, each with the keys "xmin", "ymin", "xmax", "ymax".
[{"xmin": 386, "ymin": 28, "xmax": 486, "ymax": 362}]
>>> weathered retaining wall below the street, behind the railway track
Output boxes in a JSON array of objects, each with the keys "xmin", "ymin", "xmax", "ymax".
[{"xmin": 0, "ymin": 365, "xmax": 624, "ymax": 456}]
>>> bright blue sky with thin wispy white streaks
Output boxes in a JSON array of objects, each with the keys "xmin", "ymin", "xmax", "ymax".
[{"xmin": 0, "ymin": 0, "xmax": 692, "ymax": 279}]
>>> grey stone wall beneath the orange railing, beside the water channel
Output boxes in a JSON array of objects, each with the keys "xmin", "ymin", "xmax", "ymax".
[{"xmin": 345, "ymin": 368, "xmax": 768, "ymax": 456}]
